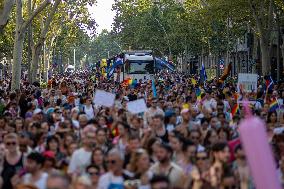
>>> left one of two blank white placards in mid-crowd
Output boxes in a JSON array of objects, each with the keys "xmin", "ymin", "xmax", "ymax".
[{"xmin": 94, "ymin": 89, "xmax": 115, "ymax": 107}]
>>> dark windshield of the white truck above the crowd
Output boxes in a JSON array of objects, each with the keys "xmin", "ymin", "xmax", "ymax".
[{"xmin": 128, "ymin": 60, "xmax": 154, "ymax": 74}]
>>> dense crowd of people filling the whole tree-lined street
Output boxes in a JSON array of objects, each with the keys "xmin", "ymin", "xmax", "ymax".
[{"xmin": 0, "ymin": 71, "xmax": 284, "ymax": 189}]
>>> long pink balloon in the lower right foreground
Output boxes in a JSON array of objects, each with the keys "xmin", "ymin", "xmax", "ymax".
[{"xmin": 240, "ymin": 117, "xmax": 281, "ymax": 189}]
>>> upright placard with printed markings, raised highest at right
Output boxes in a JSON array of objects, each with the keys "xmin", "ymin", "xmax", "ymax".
[{"xmin": 238, "ymin": 73, "xmax": 258, "ymax": 94}]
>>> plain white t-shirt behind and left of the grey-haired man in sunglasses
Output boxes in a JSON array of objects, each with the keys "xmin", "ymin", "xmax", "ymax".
[{"xmin": 68, "ymin": 148, "xmax": 92, "ymax": 174}]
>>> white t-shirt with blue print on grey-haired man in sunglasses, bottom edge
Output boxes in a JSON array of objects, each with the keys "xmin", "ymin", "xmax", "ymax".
[{"xmin": 98, "ymin": 172, "xmax": 124, "ymax": 189}]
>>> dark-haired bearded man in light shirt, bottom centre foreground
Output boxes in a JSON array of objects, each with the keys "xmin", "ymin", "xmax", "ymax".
[{"xmin": 150, "ymin": 143, "xmax": 185, "ymax": 188}]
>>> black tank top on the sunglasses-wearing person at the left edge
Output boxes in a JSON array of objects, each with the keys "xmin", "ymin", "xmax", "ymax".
[{"xmin": 2, "ymin": 155, "xmax": 23, "ymax": 189}]
